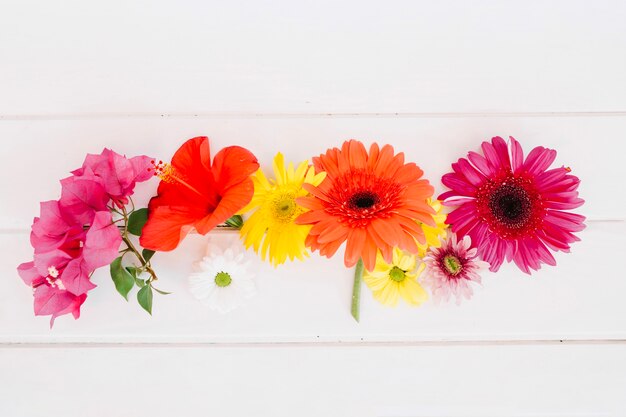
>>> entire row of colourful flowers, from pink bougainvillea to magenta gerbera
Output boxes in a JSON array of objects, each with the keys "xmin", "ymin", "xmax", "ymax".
[{"xmin": 18, "ymin": 137, "xmax": 585, "ymax": 326}]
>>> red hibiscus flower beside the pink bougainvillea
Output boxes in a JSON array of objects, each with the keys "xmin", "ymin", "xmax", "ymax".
[{"xmin": 140, "ymin": 136, "xmax": 259, "ymax": 251}]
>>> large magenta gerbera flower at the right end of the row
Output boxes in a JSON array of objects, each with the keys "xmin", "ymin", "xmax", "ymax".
[{"xmin": 439, "ymin": 137, "xmax": 585, "ymax": 274}]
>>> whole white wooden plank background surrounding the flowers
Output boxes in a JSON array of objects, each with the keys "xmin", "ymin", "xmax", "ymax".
[{"xmin": 0, "ymin": 0, "xmax": 626, "ymax": 417}]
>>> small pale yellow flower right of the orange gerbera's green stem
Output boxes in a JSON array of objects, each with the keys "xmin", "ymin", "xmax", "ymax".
[{"xmin": 363, "ymin": 248, "xmax": 428, "ymax": 306}]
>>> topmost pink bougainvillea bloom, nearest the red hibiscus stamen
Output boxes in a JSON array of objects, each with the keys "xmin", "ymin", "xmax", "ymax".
[{"xmin": 72, "ymin": 148, "xmax": 154, "ymax": 204}]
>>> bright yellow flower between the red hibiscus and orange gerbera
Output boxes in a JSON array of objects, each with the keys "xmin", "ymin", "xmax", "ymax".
[{"xmin": 241, "ymin": 152, "xmax": 326, "ymax": 266}]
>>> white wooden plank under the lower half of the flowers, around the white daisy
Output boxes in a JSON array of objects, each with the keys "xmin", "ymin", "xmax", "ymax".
[{"xmin": 0, "ymin": 222, "xmax": 626, "ymax": 343}]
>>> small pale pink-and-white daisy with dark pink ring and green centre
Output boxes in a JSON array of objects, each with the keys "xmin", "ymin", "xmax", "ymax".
[{"xmin": 422, "ymin": 233, "xmax": 489, "ymax": 304}]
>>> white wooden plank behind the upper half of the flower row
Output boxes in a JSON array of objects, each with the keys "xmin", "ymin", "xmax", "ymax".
[{"xmin": 0, "ymin": 116, "xmax": 626, "ymax": 230}]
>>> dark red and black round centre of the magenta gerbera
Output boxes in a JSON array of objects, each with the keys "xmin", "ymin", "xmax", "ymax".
[{"xmin": 476, "ymin": 173, "xmax": 544, "ymax": 239}]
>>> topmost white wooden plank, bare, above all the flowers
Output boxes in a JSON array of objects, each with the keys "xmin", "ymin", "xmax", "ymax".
[{"xmin": 0, "ymin": 0, "xmax": 626, "ymax": 117}]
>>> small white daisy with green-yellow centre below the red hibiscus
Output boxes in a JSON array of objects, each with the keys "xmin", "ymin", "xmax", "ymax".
[{"xmin": 189, "ymin": 240, "xmax": 256, "ymax": 314}]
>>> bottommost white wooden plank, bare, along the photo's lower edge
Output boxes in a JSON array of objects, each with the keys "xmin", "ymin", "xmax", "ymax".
[{"xmin": 0, "ymin": 345, "xmax": 626, "ymax": 417}]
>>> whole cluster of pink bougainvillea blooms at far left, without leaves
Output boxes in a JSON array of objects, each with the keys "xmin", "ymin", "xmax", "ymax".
[{"xmin": 18, "ymin": 149, "xmax": 153, "ymax": 326}]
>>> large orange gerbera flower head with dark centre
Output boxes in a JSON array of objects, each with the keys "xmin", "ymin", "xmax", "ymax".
[{"xmin": 296, "ymin": 140, "xmax": 435, "ymax": 271}]
